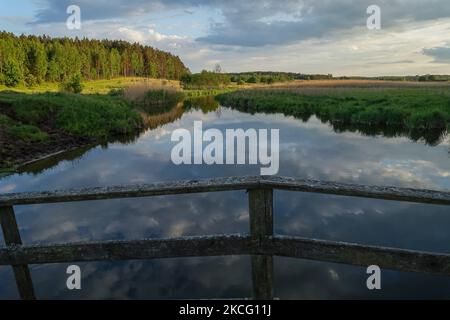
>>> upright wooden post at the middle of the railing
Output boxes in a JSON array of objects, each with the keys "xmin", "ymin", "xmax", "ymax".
[{"xmin": 248, "ymin": 189, "xmax": 273, "ymax": 300}]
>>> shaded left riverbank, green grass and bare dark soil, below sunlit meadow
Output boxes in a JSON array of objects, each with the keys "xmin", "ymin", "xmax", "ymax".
[{"xmin": 0, "ymin": 92, "xmax": 143, "ymax": 172}]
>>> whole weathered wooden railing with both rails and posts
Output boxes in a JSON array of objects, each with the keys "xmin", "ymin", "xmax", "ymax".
[{"xmin": 0, "ymin": 177, "xmax": 450, "ymax": 299}]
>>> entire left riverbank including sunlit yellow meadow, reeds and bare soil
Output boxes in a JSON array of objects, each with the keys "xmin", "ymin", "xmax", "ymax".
[{"xmin": 0, "ymin": 78, "xmax": 191, "ymax": 174}]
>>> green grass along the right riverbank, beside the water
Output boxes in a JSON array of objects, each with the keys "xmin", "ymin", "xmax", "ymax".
[{"xmin": 217, "ymin": 88, "xmax": 450, "ymax": 130}]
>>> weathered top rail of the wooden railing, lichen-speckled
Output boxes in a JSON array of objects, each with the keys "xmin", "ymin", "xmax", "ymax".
[{"xmin": 0, "ymin": 176, "xmax": 450, "ymax": 206}]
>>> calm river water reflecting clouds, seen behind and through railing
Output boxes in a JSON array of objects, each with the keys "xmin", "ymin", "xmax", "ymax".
[{"xmin": 0, "ymin": 99, "xmax": 450, "ymax": 299}]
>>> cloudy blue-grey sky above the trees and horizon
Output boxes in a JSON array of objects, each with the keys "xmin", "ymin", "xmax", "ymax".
[{"xmin": 0, "ymin": 0, "xmax": 450, "ymax": 76}]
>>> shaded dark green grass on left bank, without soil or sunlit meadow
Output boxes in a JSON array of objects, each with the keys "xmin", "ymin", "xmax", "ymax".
[{"xmin": 0, "ymin": 93, "xmax": 142, "ymax": 139}]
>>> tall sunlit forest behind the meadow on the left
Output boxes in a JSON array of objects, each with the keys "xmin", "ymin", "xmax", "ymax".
[{"xmin": 0, "ymin": 32, "xmax": 189, "ymax": 86}]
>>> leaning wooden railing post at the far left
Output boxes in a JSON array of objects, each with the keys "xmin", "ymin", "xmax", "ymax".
[{"xmin": 0, "ymin": 206, "xmax": 36, "ymax": 300}]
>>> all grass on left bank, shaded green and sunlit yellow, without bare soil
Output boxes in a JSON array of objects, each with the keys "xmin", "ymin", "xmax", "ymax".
[{"xmin": 0, "ymin": 78, "xmax": 162, "ymax": 142}]
